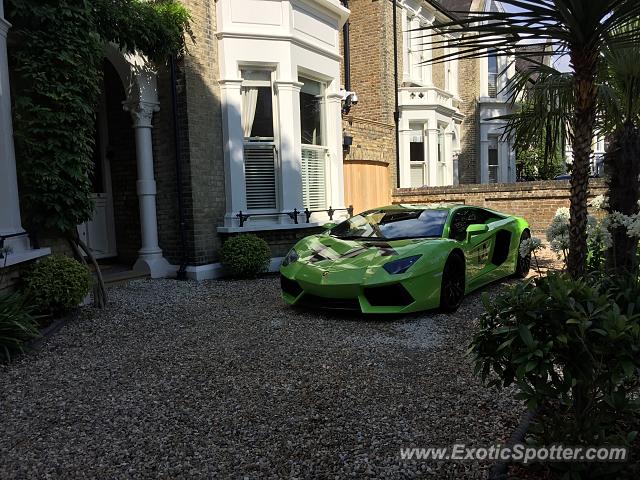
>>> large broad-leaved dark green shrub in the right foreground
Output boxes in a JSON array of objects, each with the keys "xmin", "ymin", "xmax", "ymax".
[{"xmin": 470, "ymin": 275, "xmax": 640, "ymax": 478}]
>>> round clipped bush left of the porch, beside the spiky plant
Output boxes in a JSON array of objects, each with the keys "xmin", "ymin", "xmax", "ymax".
[{"xmin": 23, "ymin": 255, "xmax": 93, "ymax": 315}]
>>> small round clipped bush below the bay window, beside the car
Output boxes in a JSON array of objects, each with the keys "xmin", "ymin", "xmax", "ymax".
[{"xmin": 221, "ymin": 234, "xmax": 271, "ymax": 278}]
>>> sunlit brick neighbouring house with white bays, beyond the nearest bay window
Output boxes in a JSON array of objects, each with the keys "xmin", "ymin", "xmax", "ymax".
[{"xmin": 344, "ymin": 0, "xmax": 516, "ymax": 214}]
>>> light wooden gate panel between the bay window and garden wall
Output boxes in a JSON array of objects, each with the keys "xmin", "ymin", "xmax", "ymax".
[{"xmin": 344, "ymin": 160, "xmax": 391, "ymax": 214}]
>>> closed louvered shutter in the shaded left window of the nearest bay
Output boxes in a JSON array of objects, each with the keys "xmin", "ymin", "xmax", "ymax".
[{"xmin": 244, "ymin": 142, "xmax": 277, "ymax": 211}]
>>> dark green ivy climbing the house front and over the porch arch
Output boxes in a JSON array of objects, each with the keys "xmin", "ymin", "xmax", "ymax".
[{"xmin": 6, "ymin": 0, "xmax": 189, "ymax": 235}]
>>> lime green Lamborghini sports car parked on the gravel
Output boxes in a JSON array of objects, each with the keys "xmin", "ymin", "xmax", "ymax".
[{"xmin": 280, "ymin": 205, "xmax": 531, "ymax": 313}]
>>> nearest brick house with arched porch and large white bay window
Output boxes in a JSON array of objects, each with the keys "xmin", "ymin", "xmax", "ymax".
[{"xmin": 0, "ymin": 0, "xmax": 349, "ymax": 279}]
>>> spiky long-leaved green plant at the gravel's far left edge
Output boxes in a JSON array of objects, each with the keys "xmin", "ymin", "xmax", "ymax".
[{"xmin": 0, "ymin": 293, "xmax": 38, "ymax": 361}]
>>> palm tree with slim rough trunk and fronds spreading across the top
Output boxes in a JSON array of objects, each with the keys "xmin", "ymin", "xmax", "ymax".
[{"xmin": 427, "ymin": 0, "xmax": 640, "ymax": 277}]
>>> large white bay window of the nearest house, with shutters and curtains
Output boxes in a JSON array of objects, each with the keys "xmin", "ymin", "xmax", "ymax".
[{"xmin": 216, "ymin": 0, "xmax": 349, "ymax": 233}]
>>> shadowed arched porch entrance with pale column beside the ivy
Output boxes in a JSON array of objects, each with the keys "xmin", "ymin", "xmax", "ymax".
[{"xmin": 78, "ymin": 45, "xmax": 173, "ymax": 278}]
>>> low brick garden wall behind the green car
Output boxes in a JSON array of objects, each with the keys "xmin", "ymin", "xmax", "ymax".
[{"xmin": 393, "ymin": 179, "xmax": 606, "ymax": 234}]
